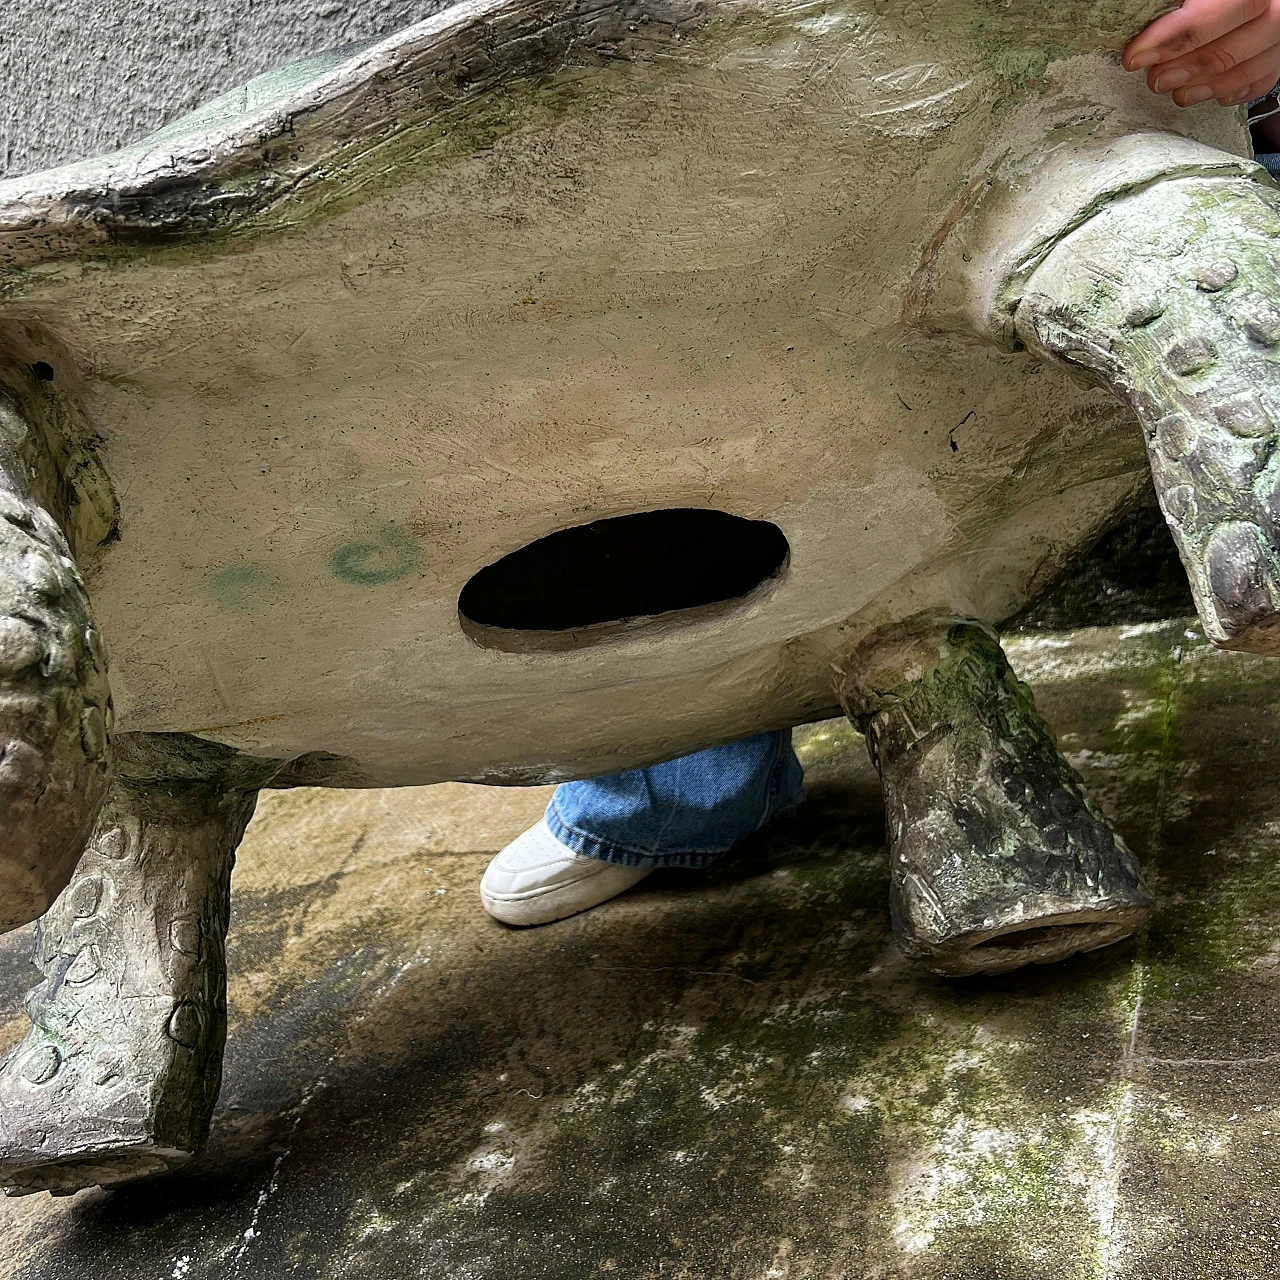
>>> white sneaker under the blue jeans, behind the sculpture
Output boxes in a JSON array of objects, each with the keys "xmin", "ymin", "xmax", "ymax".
[{"xmin": 480, "ymin": 820, "xmax": 652, "ymax": 924}]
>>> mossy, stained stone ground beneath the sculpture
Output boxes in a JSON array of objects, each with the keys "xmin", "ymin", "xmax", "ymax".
[{"xmin": 0, "ymin": 622, "xmax": 1280, "ymax": 1280}]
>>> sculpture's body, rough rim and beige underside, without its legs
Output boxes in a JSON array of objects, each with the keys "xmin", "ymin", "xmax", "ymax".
[{"xmin": 0, "ymin": 0, "xmax": 1266, "ymax": 785}]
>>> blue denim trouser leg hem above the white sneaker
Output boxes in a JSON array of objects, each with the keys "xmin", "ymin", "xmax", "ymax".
[{"xmin": 547, "ymin": 730, "xmax": 804, "ymax": 868}]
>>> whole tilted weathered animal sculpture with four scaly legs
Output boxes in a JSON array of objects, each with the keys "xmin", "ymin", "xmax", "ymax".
[{"xmin": 0, "ymin": 0, "xmax": 1280, "ymax": 1192}]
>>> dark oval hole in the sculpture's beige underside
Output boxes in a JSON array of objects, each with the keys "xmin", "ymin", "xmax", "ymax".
[{"xmin": 458, "ymin": 508, "xmax": 788, "ymax": 631}]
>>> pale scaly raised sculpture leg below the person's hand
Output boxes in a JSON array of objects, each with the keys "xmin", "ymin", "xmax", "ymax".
[{"xmin": 1016, "ymin": 178, "xmax": 1280, "ymax": 654}]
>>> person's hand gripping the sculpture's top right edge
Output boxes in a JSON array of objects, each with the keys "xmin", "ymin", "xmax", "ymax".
[{"xmin": 1124, "ymin": 0, "xmax": 1280, "ymax": 106}]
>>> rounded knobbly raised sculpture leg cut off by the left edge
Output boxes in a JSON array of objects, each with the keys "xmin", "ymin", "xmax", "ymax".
[{"xmin": 0, "ymin": 401, "xmax": 110, "ymax": 933}]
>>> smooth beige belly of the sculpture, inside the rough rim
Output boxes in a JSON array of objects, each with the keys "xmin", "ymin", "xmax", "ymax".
[{"xmin": 5, "ymin": 22, "xmax": 1143, "ymax": 782}]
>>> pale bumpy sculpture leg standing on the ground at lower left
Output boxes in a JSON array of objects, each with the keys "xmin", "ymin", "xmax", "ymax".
[{"xmin": 0, "ymin": 783, "xmax": 255, "ymax": 1194}]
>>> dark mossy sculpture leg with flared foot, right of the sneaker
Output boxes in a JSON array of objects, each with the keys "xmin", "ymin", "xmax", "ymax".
[{"xmin": 846, "ymin": 623, "xmax": 1153, "ymax": 975}]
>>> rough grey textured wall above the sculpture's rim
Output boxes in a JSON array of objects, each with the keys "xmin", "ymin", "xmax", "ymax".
[{"xmin": 0, "ymin": 0, "xmax": 445, "ymax": 177}]
